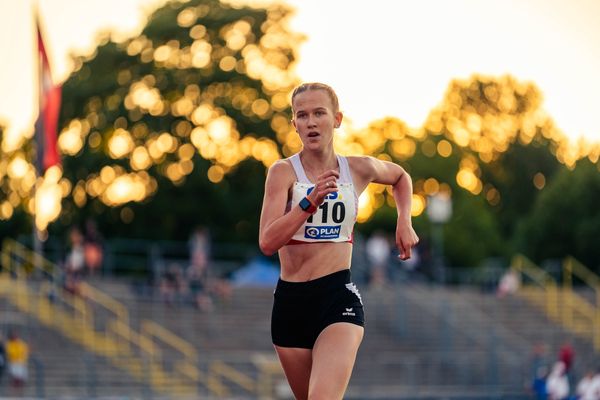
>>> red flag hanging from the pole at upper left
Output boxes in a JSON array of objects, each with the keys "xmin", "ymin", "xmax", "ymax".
[{"xmin": 35, "ymin": 19, "xmax": 61, "ymax": 173}]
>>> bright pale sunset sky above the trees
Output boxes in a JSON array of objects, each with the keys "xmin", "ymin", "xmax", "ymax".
[{"xmin": 0, "ymin": 0, "xmax": 600, "ymax": 141}]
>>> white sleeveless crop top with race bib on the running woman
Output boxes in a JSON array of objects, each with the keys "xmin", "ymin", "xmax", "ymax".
[{"xmin": 287, "ymin": 154, "xmax": 358, "ymax": 244}]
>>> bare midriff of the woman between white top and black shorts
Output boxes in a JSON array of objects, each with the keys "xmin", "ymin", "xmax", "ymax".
[{"xmin": 279, "ymin": 242, "xmax": 352, "ymax": 282}]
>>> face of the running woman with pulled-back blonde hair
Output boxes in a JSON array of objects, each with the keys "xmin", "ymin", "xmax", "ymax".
[{"xmin": 292, "ymin": 90, "xmax": 342, "ymax": 149}]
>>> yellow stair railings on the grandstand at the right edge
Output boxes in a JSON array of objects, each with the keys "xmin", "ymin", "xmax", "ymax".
[{"xmin": 511, "ymin": 255, "xmax": 600, "ymax": 350}]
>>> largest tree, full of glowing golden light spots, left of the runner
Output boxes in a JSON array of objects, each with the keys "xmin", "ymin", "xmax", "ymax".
[{"xmin": 52, "ymin": 0, "xmax": 300, "ymax": 241}]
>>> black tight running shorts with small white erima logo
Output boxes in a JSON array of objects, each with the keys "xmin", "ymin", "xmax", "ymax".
[{"xmin": 271, "ymin": 269, "xmax": 365, "ymax": 349}]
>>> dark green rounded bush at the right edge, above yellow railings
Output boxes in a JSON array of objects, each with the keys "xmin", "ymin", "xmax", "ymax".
[{"xmin": 517, "ymin": 159, "xmax": 600, "ymax": 273}]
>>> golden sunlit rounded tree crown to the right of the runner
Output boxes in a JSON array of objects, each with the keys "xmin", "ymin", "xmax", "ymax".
[{"xmin": 428, "ymin": 76, "xmax": 566, "ymax": 240}]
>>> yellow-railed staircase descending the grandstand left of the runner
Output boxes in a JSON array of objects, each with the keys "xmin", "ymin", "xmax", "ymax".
[{"xmin": 0, "ymin": 239, "xmax": 270, "ymax": 398}]
